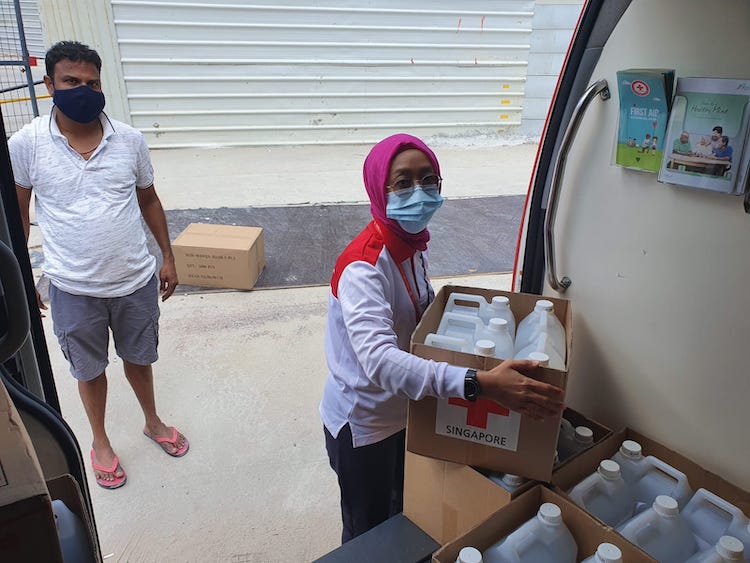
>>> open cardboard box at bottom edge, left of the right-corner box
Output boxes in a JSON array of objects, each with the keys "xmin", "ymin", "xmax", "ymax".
[{"xmin": 432, "ymin": 485, "xmax": 655, "ymax": 563}]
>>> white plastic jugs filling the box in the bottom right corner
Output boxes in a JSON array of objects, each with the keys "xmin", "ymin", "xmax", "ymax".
[{"xmin": 568, "ymin": 440, "xmax": 750, "ymax": 563}]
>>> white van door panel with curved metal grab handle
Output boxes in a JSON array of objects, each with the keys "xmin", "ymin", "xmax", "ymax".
[{"xmin": 514, "ymin": 0, "xmax": 750, "ymax": 489}]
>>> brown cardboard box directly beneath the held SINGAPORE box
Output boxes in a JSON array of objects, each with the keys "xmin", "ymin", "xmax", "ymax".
[{"xmin": 404, "ymin": 409, "xmax": 612, "ymax": 544}]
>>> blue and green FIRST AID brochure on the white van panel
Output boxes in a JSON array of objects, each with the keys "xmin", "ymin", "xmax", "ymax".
[{"xmin": 615, "ymin": 68, "xmax": 674, "ymax": 172}]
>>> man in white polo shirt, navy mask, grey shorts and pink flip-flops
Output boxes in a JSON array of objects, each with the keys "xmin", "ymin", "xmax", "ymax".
[{"xmin": 8, "ymin": 41, "xmax": 189, "ymax": 489}]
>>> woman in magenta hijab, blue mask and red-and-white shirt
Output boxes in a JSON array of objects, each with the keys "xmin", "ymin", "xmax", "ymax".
[{"xmin": 320, "ymin": 134, "xmax": 563, "ymax": 543}]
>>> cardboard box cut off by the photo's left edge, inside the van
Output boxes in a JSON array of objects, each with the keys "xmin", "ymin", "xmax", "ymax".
[{"xmin": 0, "ymin": 383, "xmax": 62, "ymax": 563}]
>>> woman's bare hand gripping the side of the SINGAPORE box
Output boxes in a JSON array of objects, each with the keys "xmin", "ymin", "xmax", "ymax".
[{"xmin": 477, "ymin": 360, "xmax": 565, "ymax": 420}]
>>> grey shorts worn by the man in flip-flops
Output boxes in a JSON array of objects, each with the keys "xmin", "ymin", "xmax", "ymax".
[{"xmin": 49, "ymin": 276, "xmax": 159, "ymax": 381}]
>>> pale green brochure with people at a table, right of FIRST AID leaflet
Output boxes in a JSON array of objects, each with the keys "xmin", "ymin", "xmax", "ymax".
[{"xmin": 659, "ymin": 78, "xmax": 750, "ymax": 195}]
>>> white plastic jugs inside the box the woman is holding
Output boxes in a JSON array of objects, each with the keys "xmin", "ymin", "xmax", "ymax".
[{"xmin": 425, "ymin": 292, "xmax": 566, "ymax": 370}]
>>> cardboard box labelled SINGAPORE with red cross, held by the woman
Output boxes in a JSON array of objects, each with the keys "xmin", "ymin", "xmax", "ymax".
[{"xmin": 406, "ymin": 285, "xmax": 572, "ymax": 481}]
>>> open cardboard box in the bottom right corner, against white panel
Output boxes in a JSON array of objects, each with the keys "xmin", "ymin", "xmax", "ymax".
[{"xmin": 552, "ymin": 428, "xmax": 750, "ymax": 524}]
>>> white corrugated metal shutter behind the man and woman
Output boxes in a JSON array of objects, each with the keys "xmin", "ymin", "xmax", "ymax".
[{"xmin": 111, "ymin": 0, "xmax": 534, "ymax": 148}]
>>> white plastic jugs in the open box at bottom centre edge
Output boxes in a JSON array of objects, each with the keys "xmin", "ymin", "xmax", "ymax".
[{"xmin": 456, "ymin": 502, "xmax": 622, "ymax": 563}]
